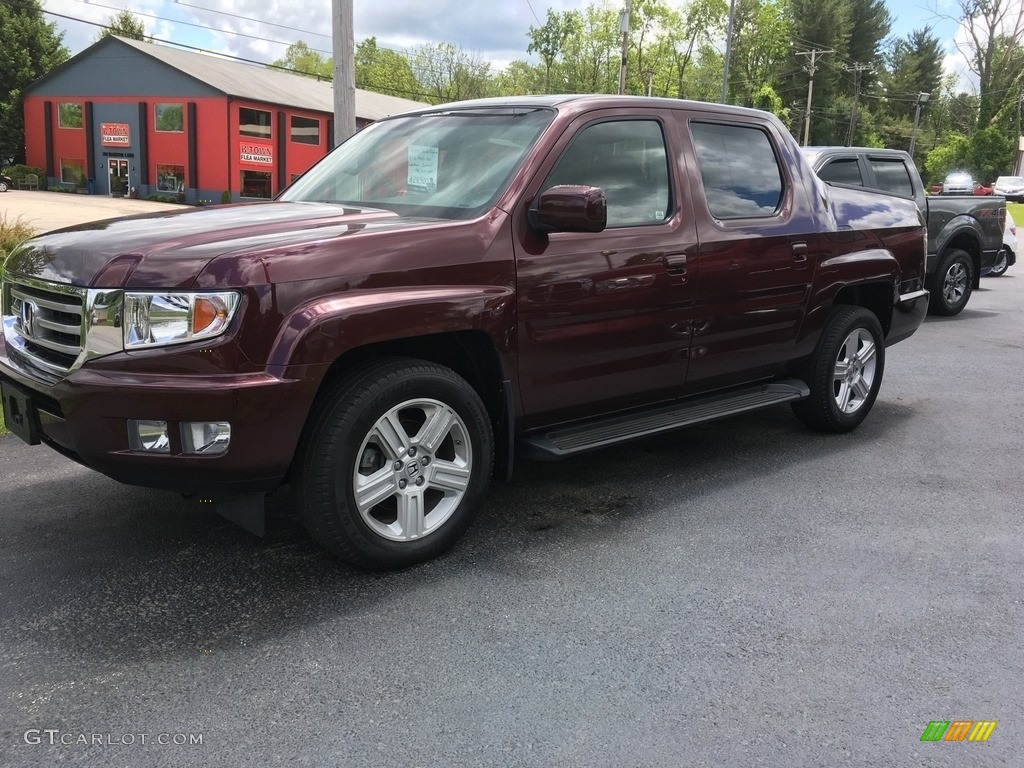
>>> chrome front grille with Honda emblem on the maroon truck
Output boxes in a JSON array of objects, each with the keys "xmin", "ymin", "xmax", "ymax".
[{"xmin": 3, "ymin": 278, "xmax": 86, "ymax": 374}]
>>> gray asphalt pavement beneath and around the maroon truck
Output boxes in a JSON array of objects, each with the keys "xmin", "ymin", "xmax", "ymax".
[{"xmin": 0, "ymin": 201, "xmax": 1024, "ymax": 768}]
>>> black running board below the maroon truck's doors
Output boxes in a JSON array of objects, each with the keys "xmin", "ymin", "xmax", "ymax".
[{"xmin": 519, "ymin": 379, "xmax": 810, "ymax": 461}]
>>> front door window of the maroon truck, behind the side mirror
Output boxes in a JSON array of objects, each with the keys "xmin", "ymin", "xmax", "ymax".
[{"xmin": 544, "ymin": 120, "xmax": 669, "ymax": 226}]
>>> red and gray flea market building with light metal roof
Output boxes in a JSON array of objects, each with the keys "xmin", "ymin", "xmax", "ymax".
[{"xmin": 25, "ymin": 36, "xmax": 423, "ymax": 203}]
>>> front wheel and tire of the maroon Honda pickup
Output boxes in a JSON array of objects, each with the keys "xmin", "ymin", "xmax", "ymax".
[{"xmin": 296, "ymin": 359, "xmax": 494, "ymax": 569}]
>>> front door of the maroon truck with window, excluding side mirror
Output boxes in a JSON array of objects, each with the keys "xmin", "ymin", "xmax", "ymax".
[{"xmin": 514, "ymin": 109, "xmax": 696, "ymax": 426}]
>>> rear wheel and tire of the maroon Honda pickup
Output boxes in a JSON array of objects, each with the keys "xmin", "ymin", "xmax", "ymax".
[{"xmin": 793, "ymin": 306, "xmax": 886, "ymax": 432}]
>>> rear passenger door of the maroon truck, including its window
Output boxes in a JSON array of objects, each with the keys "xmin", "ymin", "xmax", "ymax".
[{"xmin": 679, "ymin": 111, "xmax": 824, "ymax": 391}]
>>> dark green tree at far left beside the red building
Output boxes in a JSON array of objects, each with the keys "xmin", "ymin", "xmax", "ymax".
[{"xmin": 0, "ymin": 0, "xmax": 68, "ymax": 164}]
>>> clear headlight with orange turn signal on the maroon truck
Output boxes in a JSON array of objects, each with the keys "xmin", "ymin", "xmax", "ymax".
[{"xmin": 124, "ymin": 291, "xmax": 241, "ymax": 349}]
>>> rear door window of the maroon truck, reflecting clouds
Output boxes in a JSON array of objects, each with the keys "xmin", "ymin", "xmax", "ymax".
[{"xmin": 690, "ymin": 122, "xmax": 782, "ymax": 219}]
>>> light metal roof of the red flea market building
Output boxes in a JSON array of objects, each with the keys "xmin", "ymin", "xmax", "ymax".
[{"xmin": 111, "ymin": 35, "xmax": 425, "ymax": 120}]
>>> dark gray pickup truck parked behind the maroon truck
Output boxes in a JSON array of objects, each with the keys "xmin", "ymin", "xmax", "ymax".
[{"xmin": 802, "ymin": 146, "xmax": 1007, "ymax": 315}]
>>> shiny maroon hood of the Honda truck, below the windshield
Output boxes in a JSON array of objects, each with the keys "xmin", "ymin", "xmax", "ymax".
[{"xmin": 5, "ymin": 202, "xmax": 430, "ymax": 289}]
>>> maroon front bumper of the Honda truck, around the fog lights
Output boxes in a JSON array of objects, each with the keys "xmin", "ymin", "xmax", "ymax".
[{"xmin": 0, "ymin": 347, "xmax": 316, "ymax": 497}]
